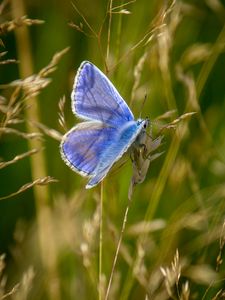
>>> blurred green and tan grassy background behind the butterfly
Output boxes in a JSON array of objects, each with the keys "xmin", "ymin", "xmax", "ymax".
[{"xmin": 0, "ymin": 0, "xmax": 225, "ymax": 300}]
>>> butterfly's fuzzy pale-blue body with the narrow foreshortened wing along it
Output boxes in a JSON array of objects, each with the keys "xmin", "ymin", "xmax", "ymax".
[{"xmin": 86, "ymin": 120, "xmax": 146, "ymax": 188}]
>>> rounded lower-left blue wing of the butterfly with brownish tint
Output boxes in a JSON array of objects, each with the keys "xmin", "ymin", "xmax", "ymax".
[{"xmin": 60, "ymin": 121, "xmax": 116, "ymax": 176}]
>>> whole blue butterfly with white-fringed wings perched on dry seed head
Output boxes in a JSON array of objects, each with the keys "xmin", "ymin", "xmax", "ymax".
[{"xmin": 60, "ymin": 61, "xmax": 149, "ymax": 189}]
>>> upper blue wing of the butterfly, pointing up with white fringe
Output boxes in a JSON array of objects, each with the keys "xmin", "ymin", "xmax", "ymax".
[{"xmin": 71, "ymin": 61, "xmax": 134, "ymax": 127}]
